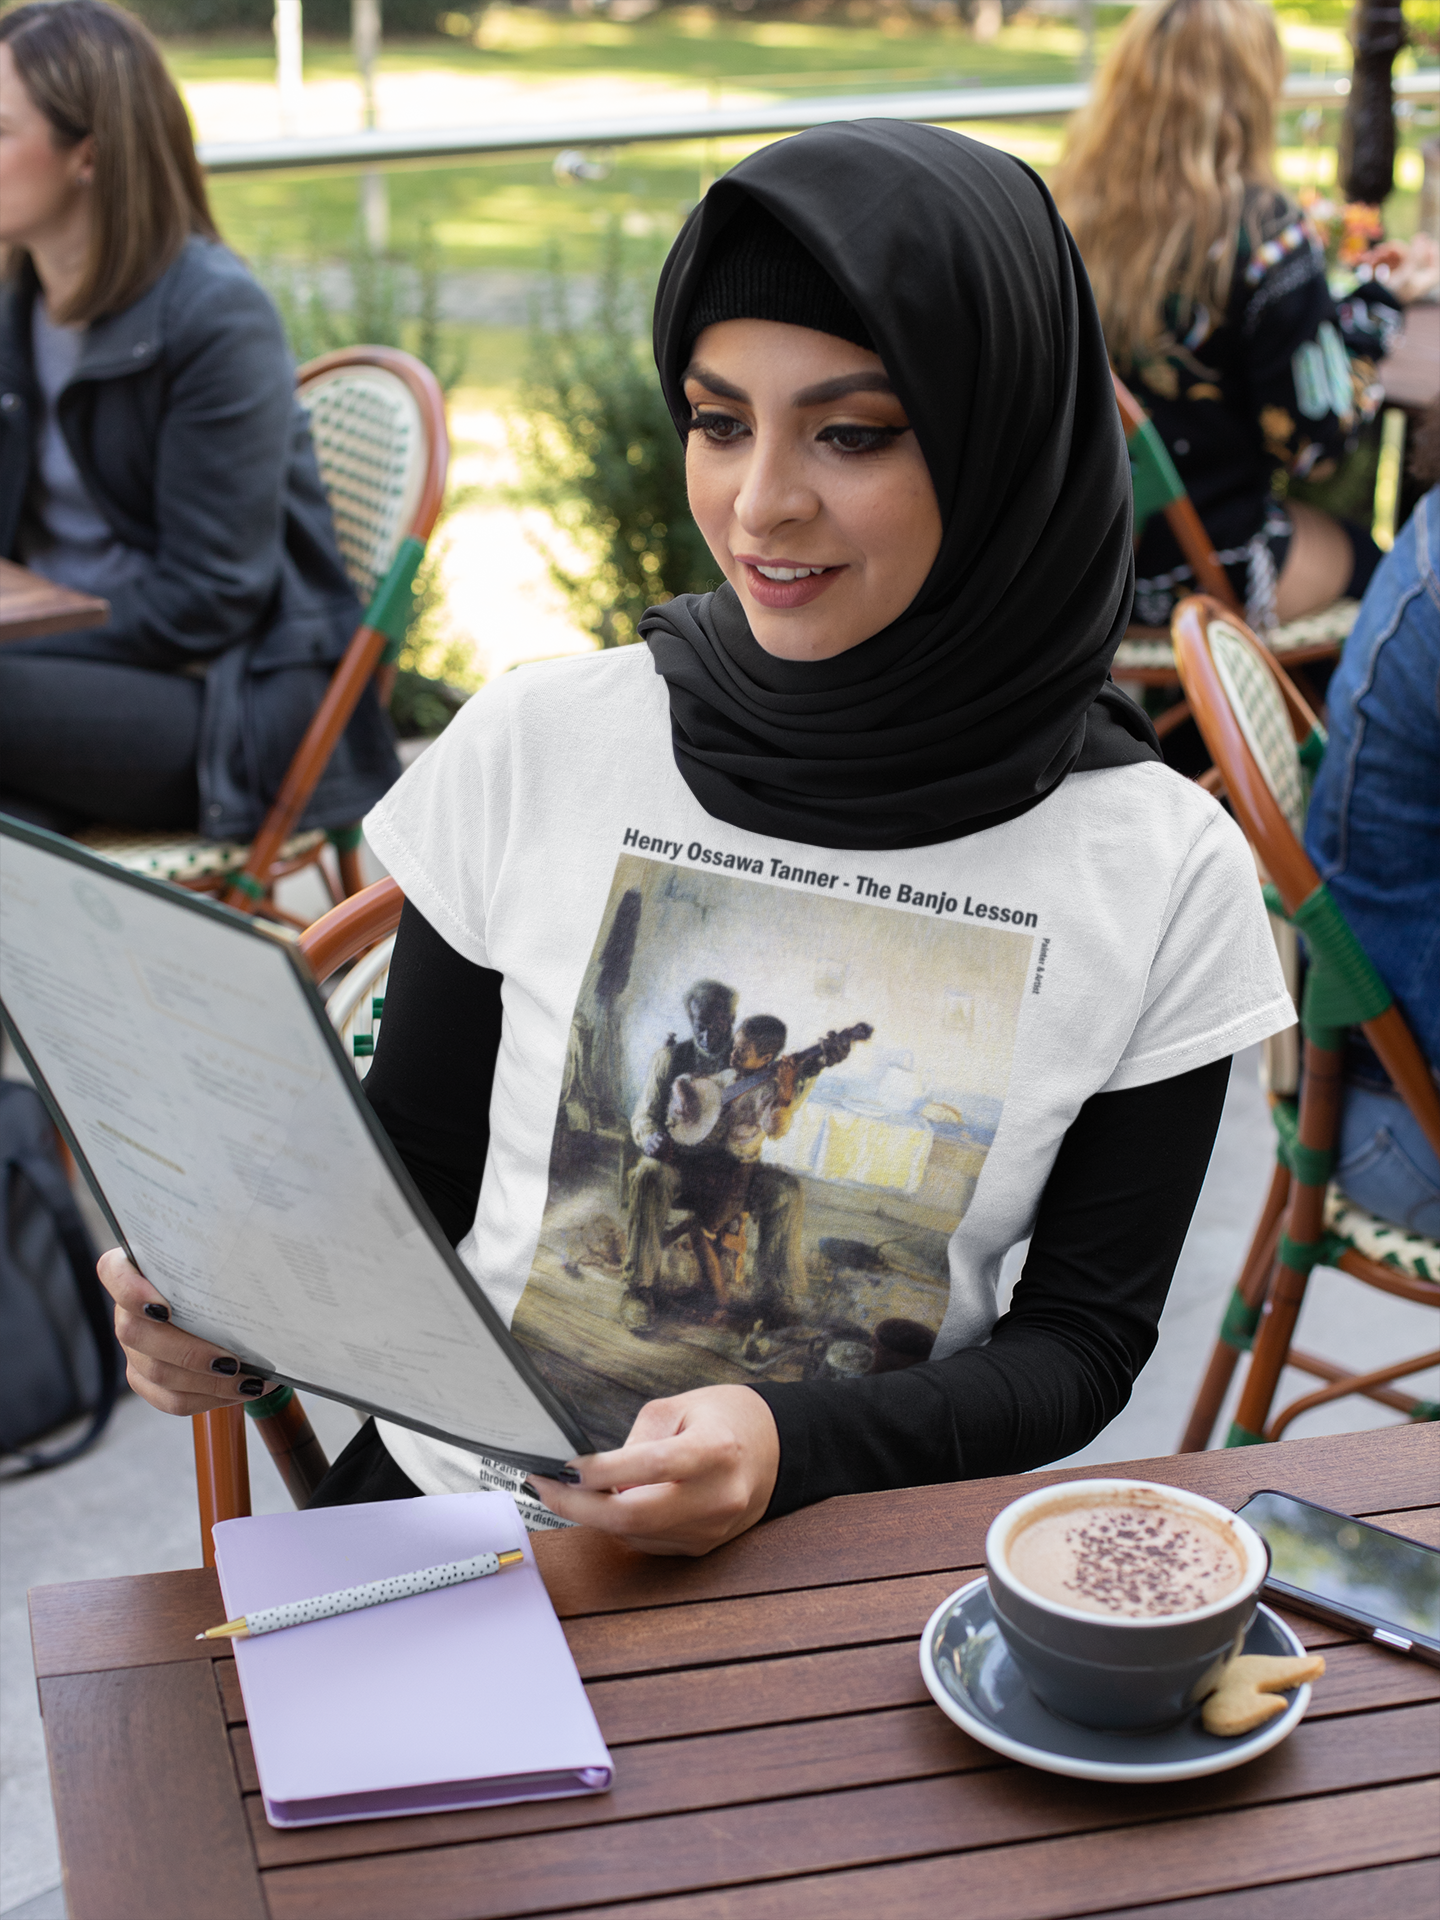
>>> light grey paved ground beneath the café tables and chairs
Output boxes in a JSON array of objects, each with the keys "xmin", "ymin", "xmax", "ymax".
[{"xmin": 0, "ymin": 1054, "xmax": 1440, "ymax": 1920}]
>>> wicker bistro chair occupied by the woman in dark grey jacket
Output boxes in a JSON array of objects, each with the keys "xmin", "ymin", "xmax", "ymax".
[{"xmin": 79, "ymin": 348, "xmax": 449, "ymax": 925}]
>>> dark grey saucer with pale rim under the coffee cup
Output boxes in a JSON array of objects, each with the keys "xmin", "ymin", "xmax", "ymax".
[{"xmin": 920, "ymin": 1576, "xmax": 1309, "ymax": 1784}]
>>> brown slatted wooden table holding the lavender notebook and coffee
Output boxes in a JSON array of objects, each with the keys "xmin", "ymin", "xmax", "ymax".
[{"xmin": 31, "ymin": 1427, "xmax": 1440, "ymax": 1920}]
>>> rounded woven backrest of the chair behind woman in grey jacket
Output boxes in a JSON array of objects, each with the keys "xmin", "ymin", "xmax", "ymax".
[{"xmin": 296, "ymin": 348, "xmax": 449, "ymax": 607}]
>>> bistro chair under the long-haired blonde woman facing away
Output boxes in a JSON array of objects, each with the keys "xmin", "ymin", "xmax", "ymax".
[{"xmin": 1110, "ymin": 372, "xmax": 1359, "ymax": 739}]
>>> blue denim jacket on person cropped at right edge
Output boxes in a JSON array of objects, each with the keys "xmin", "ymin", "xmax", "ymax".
[{"xmin": 1306, "ymin": 488, "xmax": 1440, "ymax": 1066}]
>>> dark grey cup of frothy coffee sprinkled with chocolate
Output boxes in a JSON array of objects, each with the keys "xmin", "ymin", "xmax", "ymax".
[{"xmin": 985, "ymin": 1480, "xmax": 1269, "ymax": 1732}]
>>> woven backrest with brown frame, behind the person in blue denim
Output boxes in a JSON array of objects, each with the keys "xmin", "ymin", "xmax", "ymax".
[{"xmin": 1171, "ymin": 593, "xmax": 1440, "ymax": 1152}]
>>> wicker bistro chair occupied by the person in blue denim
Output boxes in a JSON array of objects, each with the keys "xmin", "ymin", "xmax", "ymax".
[{"xmin": 1173, "ymin": 595, "xmax": 1440, "ymax": 1453}]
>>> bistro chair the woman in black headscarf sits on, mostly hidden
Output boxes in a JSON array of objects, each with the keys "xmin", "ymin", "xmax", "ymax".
[{"xmin": 192, "ymin": 879, "xmax": 403, "ymax": 1567}]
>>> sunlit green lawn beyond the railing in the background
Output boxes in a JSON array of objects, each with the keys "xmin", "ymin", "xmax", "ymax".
[{"xmin": 174, "ymin": 0, "xmax": 1440, "ymax": 386}]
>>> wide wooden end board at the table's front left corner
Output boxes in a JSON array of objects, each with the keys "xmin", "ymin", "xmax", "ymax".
[{"xmin": 40, "ymin": 1661, "xmax": 269, "ymax": 1920}]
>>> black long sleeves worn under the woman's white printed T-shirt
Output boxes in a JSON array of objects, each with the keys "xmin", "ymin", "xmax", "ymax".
[{"xmin": 365, "ymin": 902, "xmax": 1231, "ymax": 1517}]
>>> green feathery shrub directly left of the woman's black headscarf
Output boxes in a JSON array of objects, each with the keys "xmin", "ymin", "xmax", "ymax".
[{"xmin": 511, "ymin": 227, "xmax": 720, "ymax": 647}]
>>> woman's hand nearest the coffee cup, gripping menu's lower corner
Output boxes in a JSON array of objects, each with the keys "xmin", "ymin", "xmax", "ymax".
[{"xmin": 530, "ymin": 1386, "xmax": 780, "ymax": 1553}]
